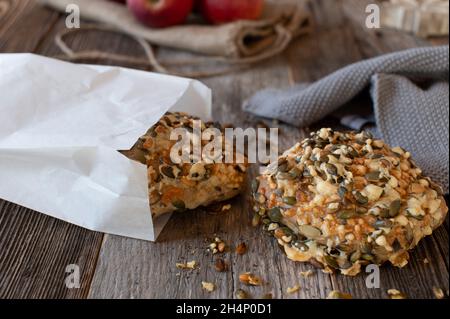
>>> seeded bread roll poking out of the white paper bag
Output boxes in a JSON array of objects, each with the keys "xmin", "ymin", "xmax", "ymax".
[{"xmin": 122, "ymin": 113, "xmax": 247, "ymax": 217}]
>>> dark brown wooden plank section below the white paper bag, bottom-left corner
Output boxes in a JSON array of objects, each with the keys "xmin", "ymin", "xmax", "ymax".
[{"xmin": 0, "ymin": 201, "xmax": 102, "ymax": 298}]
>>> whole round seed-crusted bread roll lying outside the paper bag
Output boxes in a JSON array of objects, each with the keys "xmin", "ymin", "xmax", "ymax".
[{"xmin": 252, "ymin": 128, "xmax": 448, "ymax": 275}]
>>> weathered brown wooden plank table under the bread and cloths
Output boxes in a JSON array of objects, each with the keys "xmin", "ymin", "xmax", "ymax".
[{"xmin": 0, "ymin": 0, "xmax": 449, "ymax": 298}]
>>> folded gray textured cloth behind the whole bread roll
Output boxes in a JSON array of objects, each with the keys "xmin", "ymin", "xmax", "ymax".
[{"xmin": 243, "ymin": 46, "xmax": 449, "ymax": 193}]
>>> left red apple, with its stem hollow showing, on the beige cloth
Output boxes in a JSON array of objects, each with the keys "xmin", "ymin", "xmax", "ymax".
[{"xmin": 127, "ymin": 0, "xmax": 194, "ymax": 28}]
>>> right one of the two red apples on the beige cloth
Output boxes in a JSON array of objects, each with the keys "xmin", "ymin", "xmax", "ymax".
[{"xmin": 199, "ymin": 0, "xmax": 264, "ymax": 24}]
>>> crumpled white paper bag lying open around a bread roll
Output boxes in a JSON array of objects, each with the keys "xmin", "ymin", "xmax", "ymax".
[{"xmin": 0, "ymin": 54, "xmax": 211, "ymax": 240}]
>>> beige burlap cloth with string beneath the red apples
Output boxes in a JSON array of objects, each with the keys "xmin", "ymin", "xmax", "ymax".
[{"xmin": 38, "ymin": 0, "xmax": 312, "ymax": 77}]
